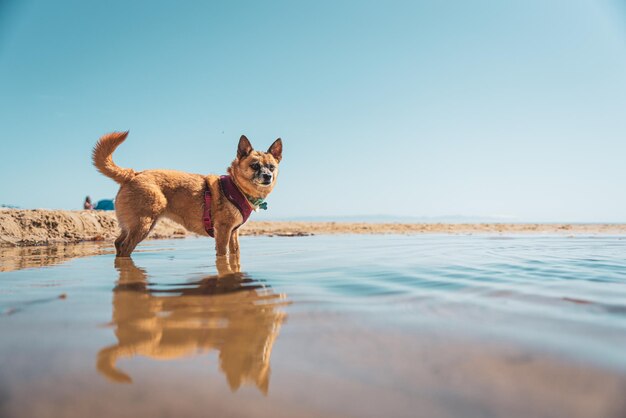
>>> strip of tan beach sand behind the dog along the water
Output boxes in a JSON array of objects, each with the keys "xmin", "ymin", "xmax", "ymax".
[{"xmin": 0, "ymin": 209, "xmax": 626, "ymax": 247}]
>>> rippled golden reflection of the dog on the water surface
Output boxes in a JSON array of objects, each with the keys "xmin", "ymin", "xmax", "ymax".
[{"xmin": 97, "ymin": 258, "xmax": 286, "ymax": 394}]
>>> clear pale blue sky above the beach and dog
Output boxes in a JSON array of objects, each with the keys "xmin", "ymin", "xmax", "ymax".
[{"xmin": 0, "ymin": 0, "xmax": 626, "ymax": 222}]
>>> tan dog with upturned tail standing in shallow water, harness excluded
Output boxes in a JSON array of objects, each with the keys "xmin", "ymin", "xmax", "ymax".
[{"xmin": 93, "ymin": 132, "xmax": 283, "ymax": 257}]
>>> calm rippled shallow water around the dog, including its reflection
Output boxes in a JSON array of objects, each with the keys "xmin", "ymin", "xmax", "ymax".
[{"xmin": 0, "ymin": 235, "xmax": 626, "ymax": 417}]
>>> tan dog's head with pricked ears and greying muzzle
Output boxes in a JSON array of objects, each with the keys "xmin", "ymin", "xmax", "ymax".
[{"xmin": 228, "ymin": 135, "xmax": 283, "ymax": 197}]
